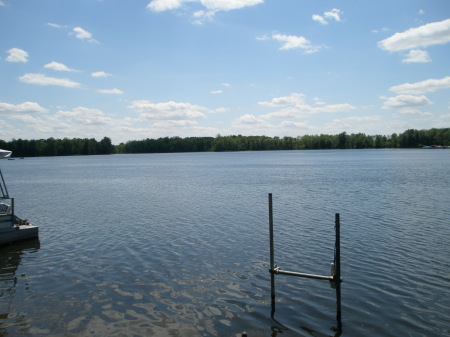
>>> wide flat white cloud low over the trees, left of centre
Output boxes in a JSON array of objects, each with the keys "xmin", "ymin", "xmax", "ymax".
[{"xmin": 129, "ymin": 100, "xmax": 211, "ymax": 120}]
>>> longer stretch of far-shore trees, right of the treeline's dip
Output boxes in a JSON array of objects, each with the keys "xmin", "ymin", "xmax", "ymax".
[{"xmin": 116, "ymin": 128, "xmax": 450, "ymax": 153}]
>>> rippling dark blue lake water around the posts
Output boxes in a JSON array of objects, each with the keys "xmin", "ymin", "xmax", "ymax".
[{"xmin": 0, "ymin": 150, "xmax": 450, "ymax": 337}]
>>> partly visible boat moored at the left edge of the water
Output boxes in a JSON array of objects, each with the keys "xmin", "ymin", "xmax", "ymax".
[{"xmin": 0, "ymin": 149, "xmax": 39, "ymax": 245}]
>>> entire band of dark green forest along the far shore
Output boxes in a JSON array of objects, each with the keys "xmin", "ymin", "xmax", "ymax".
[{"xmin": 0, "ymin": 128, "xmax": 450, "ymax": 157}]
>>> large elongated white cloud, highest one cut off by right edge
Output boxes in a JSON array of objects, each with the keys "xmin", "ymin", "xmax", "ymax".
[{"xmin": 378, "ymin": 19, "xmax": 450, "ymax": 52}]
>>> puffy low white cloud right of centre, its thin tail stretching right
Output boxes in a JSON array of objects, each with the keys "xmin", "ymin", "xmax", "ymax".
[{"xmin": 258, "ymin": 93, "xmax": 356, "ymax": 118}]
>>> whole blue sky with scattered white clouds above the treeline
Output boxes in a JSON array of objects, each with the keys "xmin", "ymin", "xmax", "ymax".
[{"xmin": 0, "ymin": 0, "xmax": 450, "ymax": 144}]
